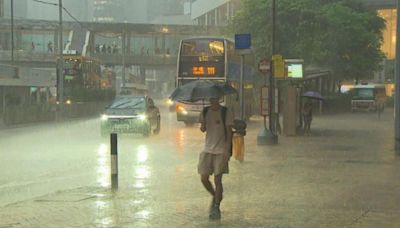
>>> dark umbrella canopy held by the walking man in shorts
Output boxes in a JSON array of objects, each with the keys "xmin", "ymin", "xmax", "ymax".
[{"xmin": 170, "ymin": 80, "xmax": 237, "ymax": 102}]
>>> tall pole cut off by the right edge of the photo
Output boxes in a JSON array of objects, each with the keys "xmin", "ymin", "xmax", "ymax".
[{"xmin": 394, "ymin": 0, "xmax": 400, "ymax": 155}]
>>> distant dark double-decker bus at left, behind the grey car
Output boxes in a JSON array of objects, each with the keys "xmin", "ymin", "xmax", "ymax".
[{"xmin": 57, "ymin": 54, "xmax": 112, "ymax": 103}]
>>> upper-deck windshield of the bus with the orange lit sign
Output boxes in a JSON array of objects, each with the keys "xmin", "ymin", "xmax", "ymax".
[{"xmin": 181, "ymin": 39, "xmax": 224, "ymax": 56}]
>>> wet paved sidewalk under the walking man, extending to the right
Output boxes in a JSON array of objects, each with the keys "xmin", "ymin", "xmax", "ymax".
[{"xmin": 0, "ymin": 110, "xmax": 400, "ymax": 228}]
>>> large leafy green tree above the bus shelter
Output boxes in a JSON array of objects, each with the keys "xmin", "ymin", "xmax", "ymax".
[{"xmin": 228, "ymin": 0, "xmax": 385, "ymax": 86}]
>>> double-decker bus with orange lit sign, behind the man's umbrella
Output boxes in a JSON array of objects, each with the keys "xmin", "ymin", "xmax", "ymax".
[{"xmin": 175, "ymin": 37, "xmax": 258, "ymax": 125}]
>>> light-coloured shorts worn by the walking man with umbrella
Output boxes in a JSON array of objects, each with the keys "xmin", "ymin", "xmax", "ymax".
[{"xmin": 197, "ymin": 152, "xmax": 229, "ymax": 175}]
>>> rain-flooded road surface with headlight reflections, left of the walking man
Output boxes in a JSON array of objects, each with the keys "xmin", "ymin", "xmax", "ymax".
[{"xmin": 0, "ymin": 104, "xmax": 203, "ymax": 206}]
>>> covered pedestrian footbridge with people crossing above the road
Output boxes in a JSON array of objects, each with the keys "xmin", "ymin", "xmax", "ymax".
[{"xmin": 0, "ymin": 19, "xmax": 219, "ymax": 69}]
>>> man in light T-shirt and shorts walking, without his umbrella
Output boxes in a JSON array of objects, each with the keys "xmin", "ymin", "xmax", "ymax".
[{"xmin": 198, "ymin": 95, "xmax": 233, "ymax": 219}]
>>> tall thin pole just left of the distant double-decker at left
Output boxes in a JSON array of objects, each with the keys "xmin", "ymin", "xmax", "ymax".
[{"xmin": 57, "ymin": 0, "xmax": 64, "ymax": 117}]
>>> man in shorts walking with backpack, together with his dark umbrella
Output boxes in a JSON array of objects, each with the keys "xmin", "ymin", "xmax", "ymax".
[{"xmin": 170, "ymin": 80, "xmax": 236, "ymax": 220}]
